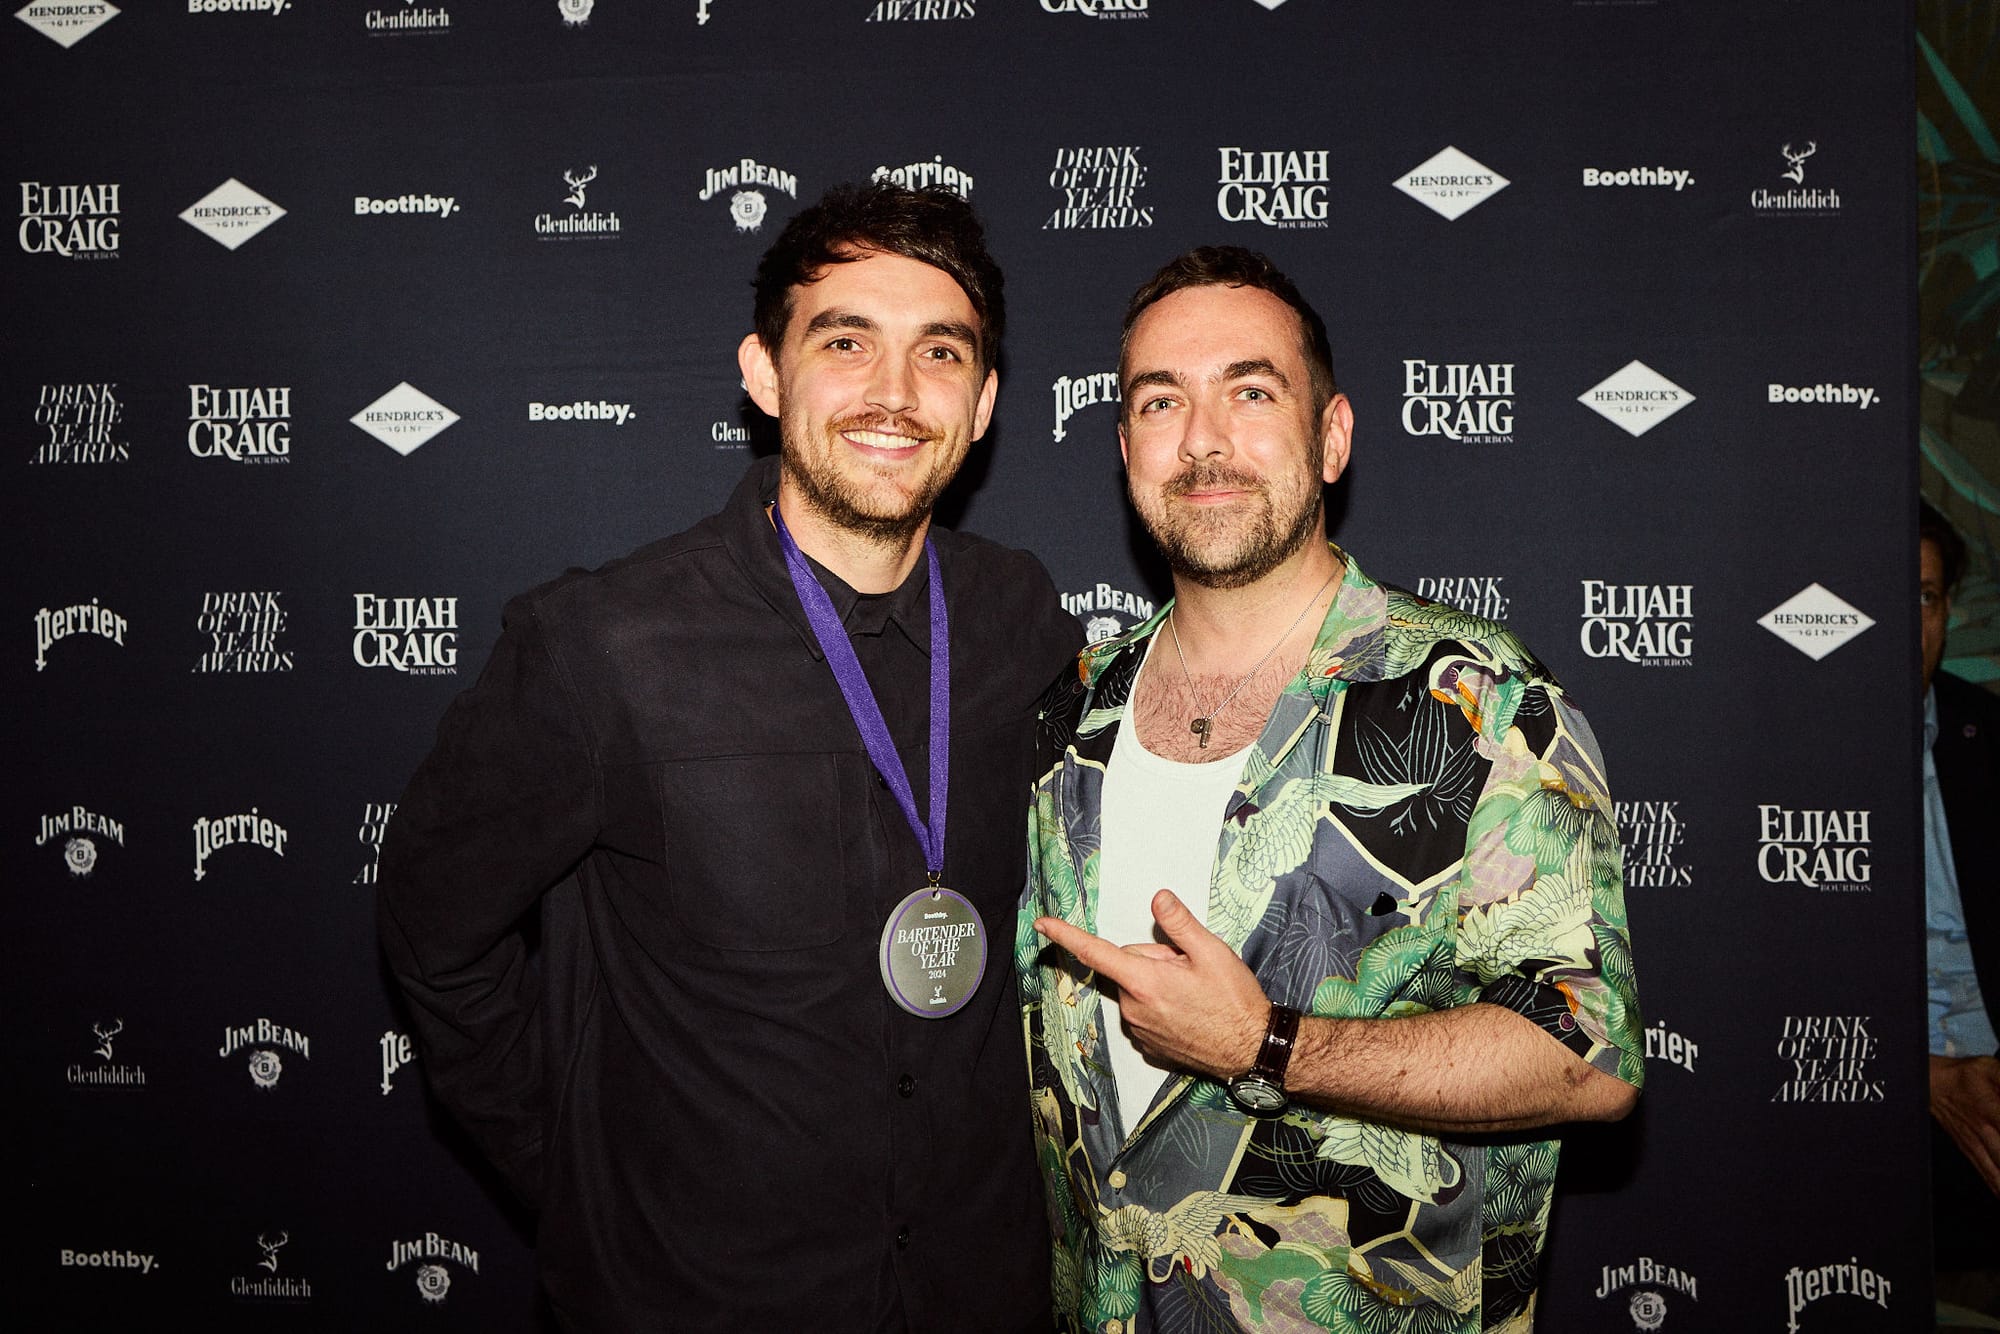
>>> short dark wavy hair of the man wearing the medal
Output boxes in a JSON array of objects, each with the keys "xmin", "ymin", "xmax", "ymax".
[{"xmin": 752, "ymin": 182, "xmax": 1006, "ymax": 370}]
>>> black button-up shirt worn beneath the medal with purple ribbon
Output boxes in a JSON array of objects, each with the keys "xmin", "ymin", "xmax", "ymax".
[{"xmin": 382, "ymin": 460, "xmax": 1082, "ymax": 1332}]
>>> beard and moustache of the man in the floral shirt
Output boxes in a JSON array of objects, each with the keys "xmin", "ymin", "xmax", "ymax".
[{"xmin": 1126, "ymin": 462, "xmax": 1324, "ymax": 588}]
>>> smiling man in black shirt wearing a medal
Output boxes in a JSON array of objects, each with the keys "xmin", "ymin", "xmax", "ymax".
[{"xmin": 380, "ymin": 186, "xmax": 1082, "ymax": 1332}]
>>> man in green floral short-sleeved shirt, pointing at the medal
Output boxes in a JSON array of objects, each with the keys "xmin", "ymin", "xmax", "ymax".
[{"xmin": 1016, "ymin": 248, "xmax": 1642, "ymax": 1334}]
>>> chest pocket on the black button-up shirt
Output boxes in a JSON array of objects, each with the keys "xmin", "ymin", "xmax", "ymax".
[{"xmin": 658, "ymin": 754, "xmax": 858, "ymax": 950}]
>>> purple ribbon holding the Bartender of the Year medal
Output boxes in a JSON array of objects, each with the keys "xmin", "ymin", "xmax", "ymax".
[{"xmin": 770, "ymin": 506, "xmax": 952, "ymax": 884}]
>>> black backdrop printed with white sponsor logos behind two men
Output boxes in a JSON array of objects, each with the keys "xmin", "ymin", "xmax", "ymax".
[{"xmin": 11, "ymin": 0, "xmax": 1928, "ymax": 1334}]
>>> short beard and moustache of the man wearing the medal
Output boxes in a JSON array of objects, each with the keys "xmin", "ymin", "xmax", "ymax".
[{"xmin": 780, "ymin": 412, "xmax": 956, "ymax": 544}]
